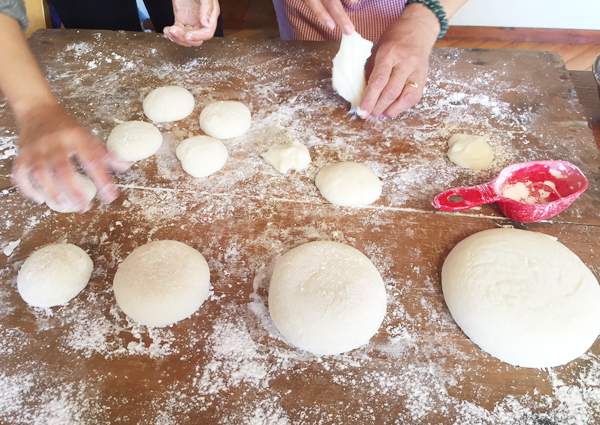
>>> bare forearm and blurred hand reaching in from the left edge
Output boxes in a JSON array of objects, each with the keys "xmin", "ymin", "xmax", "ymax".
[{"xmin": 0, "ymin": 13, "xmax": 124, "ymax": 211}]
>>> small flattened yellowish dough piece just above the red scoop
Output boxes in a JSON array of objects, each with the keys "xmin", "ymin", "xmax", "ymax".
[{"xmin": 448, "ymin": 134, "xmax": 494, "ymax": 170}]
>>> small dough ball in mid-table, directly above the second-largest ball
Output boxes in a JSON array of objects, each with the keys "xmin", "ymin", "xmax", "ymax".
[{"xmin": 315, "ymin": 162, "xmax": 382, "ymax": 207}]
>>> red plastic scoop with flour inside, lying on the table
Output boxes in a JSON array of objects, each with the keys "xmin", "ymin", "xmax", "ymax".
[{"xmin": 433, "ymin": 161, "xmax": 588, "ymax": 223}]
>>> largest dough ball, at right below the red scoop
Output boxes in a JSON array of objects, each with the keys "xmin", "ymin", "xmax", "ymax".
[{"xmin": 442, "ymin": 229, "xmax": 600, "ymax": 368}]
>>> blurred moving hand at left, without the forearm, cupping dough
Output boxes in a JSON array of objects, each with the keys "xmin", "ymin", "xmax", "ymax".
[{"xmin": 12, "ymin": 103, "xmax": 128, "ymax": 211}]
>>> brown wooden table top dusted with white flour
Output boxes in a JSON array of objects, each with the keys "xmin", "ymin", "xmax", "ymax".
[{"xmin": 0, "ymin": 30, "xmax": 600, "ymax": 424}]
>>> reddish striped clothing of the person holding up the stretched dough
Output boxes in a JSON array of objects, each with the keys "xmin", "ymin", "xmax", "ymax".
[{"xmin": 273, "ymin": 0, "xmax": 406, "ymax": 42}]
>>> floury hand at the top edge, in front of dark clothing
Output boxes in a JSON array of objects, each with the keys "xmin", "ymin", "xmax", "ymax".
[{"xmin": 163, "ymin": 0, "xmax": 219, "ymax": 47}]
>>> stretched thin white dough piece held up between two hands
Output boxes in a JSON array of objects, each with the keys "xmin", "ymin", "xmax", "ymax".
[{"xmin": 331, "ymin": 32, "xmax": 373, "ymax": 113}]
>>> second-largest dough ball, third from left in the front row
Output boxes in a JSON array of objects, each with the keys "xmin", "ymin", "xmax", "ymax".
[{"xmin": 269, "ymin": 241, "xmax": 386, "ymax": 355}]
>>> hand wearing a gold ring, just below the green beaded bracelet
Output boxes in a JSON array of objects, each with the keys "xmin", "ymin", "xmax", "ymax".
[{"xmin": 360, "ymin": 4, "xmax": 439, "ymax": 118}]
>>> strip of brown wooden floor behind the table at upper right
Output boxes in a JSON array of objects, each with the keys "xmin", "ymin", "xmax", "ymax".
[{"xmin": 437, "ymin": 39, "xmax": 600, "ymax": 71}]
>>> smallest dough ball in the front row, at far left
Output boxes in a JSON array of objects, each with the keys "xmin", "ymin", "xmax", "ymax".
[{"xmin": 17, "ymin": 243, "xmax": 94, "ymax": 308}]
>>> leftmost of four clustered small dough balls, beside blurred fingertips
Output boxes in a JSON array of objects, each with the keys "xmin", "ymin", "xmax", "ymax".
[{"xmin": 106, "ymin": 121, "xmax": 162, "ymax": 162}]
